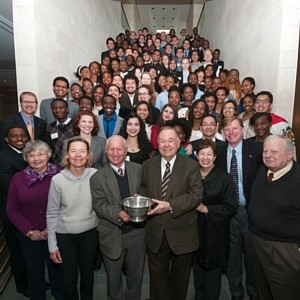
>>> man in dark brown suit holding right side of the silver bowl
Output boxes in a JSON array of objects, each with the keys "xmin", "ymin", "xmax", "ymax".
[{"xmin": 139, "ymin": 126, "xmax": 202, "ymax": 300}]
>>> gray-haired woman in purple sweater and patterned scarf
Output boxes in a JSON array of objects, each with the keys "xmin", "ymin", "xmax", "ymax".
[{"xmin": 6, "ymin": 140, "xmax": 65, "ymax": 300}]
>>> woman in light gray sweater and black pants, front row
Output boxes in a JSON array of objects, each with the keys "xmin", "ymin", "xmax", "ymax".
[{"xmin": 47, "ymin": 137, "xmax": 98, "ymax": 299}]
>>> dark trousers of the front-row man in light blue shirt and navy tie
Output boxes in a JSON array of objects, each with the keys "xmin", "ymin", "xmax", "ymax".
[{"xmin": 227, "ymin": 206, "xmax": 257, "ymax": 297}]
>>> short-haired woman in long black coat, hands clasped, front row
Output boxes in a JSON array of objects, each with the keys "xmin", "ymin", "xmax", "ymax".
[{"xmin": 193, "ymin": 139, "xmax": 237, "ymax": 300}]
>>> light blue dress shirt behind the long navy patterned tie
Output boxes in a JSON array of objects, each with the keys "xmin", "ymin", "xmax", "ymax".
[{"xmin": 227, "ymin": 141, "xmax": 246, "ymax": 206}]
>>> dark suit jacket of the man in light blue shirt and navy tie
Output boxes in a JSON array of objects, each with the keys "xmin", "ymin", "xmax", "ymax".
[{"xmin": 216, "ymin": 140, "xmax": 262, "ymax": 205}]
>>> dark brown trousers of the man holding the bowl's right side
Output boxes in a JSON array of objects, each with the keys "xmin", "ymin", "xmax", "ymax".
[{"xmin": 147, "ymin": 233, "xmax": 194, "ymax": 300}]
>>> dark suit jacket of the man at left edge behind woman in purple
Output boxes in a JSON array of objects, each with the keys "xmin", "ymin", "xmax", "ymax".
[{"xmin": 0, "ymin": 146, "xmax": 27, "ymax": 220}]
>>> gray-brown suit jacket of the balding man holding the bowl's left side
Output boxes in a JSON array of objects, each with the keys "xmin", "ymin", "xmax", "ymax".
[{"xmin": 90, "ymin": 161, "xmax": 142, "ymax": 259}]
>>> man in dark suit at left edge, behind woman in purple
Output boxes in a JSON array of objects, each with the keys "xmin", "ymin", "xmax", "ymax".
[{"xmin": 0, "ymin": 125, "xmax": 29, "ymax": 297}]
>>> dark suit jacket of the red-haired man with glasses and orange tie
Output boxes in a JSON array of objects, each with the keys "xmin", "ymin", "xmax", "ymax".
[{"xmin": 0, "ymin": 113, "xmax": 51, "ymax": 149}]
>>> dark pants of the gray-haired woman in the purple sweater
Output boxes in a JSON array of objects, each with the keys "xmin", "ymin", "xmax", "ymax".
[{"xmin": 18, "ymin": 233, "xmax": 64, "ymax": 300}]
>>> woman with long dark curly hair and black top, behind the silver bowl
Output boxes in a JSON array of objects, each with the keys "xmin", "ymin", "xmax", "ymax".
[{"xmin": 119, "ymin": 112, "xmax": 152, "ymax": 164}]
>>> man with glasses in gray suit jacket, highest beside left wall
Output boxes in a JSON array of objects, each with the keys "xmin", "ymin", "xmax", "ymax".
[{"xmin": 40, "ymin": 76, "xmax": 79, "ymax": 125}]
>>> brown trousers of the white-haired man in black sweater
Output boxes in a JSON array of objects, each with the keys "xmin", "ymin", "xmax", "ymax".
[{"xmin": 249, "ymin": 232, "xmax": 300, "ymax": 300}]
